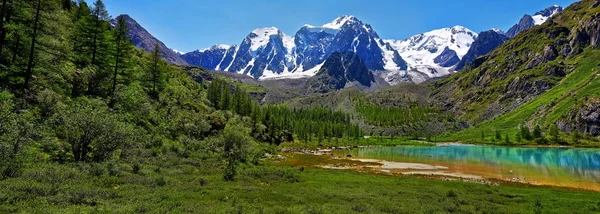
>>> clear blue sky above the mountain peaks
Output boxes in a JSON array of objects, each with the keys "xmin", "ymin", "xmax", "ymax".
[{"xmin": 97, "ymin": 0, "xmax": 575, "ymax": 52}]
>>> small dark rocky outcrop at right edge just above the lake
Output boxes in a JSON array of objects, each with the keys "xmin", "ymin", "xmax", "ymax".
[{"xmin": 558, "ymin": 97, "xmax": 600, "ymax": 136}]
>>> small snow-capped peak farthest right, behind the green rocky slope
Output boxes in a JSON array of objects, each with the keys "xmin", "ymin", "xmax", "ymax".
[{"xmin": 506, "ymin": 5, "xmax": 563, "ymax": 38}]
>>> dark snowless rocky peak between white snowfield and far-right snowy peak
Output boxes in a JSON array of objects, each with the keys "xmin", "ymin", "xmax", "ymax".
[{"xmin": 454, "ymin": 30, "xmax": 509, "ymax": 71}]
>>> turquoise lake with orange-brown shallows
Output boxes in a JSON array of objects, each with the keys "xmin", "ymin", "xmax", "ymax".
[{"xmin": 342, "ymin": 145, "xmax": 600, "ymax": 191}]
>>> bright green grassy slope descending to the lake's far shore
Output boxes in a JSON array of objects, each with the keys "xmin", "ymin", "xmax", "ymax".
[{"xmin": 439, "ymin": 49, "xmax": 600, "ymax": 142}]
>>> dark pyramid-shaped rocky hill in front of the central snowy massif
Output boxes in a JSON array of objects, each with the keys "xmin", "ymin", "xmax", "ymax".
[{"xmin": 307, "ymin": 52, "xmax": 375, "ymax": 93}]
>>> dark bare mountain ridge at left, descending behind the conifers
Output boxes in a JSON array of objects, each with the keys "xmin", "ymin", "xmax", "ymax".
[{"xmin": 111, "ymin": 14, "xmax": 187, "ymax": 65}]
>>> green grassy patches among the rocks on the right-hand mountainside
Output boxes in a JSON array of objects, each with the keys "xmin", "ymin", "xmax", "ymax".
[{"xmin": 437, "ymin": 0, "xmax": 600, "ymax": 143}]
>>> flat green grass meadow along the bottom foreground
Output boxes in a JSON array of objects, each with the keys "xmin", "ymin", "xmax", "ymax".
[{"xmin": 0, "ymin": 155, "xmax": 600, "ymax": 213}]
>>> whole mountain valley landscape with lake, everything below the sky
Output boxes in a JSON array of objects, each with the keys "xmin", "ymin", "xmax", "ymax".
[{"xmin": 0, "ymin": 0, "xmax": 600, "ymax": 213}]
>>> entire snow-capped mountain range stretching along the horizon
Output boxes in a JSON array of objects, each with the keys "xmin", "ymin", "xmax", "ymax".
[{"xmin": 181, "ymin": 5, "xmax": 563, "ymax": 84}]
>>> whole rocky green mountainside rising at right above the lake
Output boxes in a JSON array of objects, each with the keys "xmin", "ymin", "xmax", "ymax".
[{"xmin": 428, "ymin": 0, "xmax": 600, "ymax": 140}]
